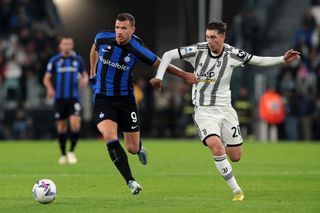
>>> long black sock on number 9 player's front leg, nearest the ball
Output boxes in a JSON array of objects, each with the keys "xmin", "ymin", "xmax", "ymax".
[{"xmin": 107, "ymin": 140, "xmax": 134, "ymax": 183}]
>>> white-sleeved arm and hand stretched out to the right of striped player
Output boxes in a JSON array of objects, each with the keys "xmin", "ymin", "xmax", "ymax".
[{"xmin": 248, "ymin": 49, "xmax": 300, "ymax": 67}]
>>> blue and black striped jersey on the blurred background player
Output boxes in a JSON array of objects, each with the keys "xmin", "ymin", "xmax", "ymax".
[{"xmin": 47, "ymin": 53, "xmax": 84, "ymax": 100}]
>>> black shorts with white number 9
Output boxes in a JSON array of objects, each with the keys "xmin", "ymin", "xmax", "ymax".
[{"xmin": 94, "ymin": 95, "xmax": 140, "ymax": 132}]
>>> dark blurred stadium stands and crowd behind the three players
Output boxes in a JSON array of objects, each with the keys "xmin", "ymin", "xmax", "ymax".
[{"xmin": 0, "ymin": 0, "xmax": 320, "ymax": 141}]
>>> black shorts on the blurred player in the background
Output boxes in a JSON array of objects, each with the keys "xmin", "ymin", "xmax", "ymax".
[{"xmin": 54, "ymin": 99, "xmax": 81, "ymax": 120}]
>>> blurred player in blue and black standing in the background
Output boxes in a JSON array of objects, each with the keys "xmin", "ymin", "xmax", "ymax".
[{"xmin": 43, "ymin": 36, "xmax": 89, "ymax": 164}]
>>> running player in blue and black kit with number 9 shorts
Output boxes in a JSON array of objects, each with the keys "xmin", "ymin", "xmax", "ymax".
[{"xmin": 90, "ymin": 13, "xmax": 195, "ymax": 194}]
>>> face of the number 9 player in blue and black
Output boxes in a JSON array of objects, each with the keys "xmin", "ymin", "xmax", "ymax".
[{"xmin": 115, "ymin": 20, "xmax": 135, "ymax": 44}]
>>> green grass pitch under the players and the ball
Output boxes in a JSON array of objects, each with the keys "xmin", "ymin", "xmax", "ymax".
[{"xmin": 0, "ymin": 139, "xmax": 320, "ymax": 213}]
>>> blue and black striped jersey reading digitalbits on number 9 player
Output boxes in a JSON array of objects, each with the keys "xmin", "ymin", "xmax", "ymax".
[{"xmin": 93, "ymin": 31, "xmax": 157, "ymax": 96}]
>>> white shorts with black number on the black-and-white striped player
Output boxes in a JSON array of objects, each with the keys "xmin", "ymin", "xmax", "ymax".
[{"xmin": 193, "ymin": 106, "xmax": 243, "ymax": 146}]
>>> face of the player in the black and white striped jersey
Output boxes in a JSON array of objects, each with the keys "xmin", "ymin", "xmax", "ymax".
[{"xmin": 206, "ymin": 30, "xmax": 225, "ymax": 54}]
